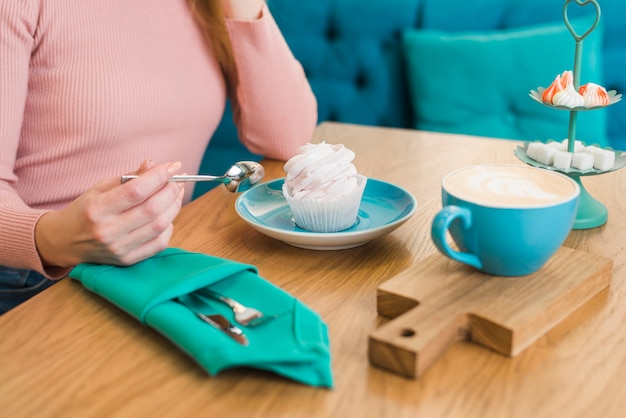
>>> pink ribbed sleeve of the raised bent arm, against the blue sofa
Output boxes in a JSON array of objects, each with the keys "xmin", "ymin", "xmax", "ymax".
[{"xmin": 228, "ymin": 5, "xmax": 317, "ymax": 160}]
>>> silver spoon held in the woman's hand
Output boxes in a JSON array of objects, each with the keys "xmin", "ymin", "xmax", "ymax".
[{"xmin": 121, "ymin": 161, "xmax": 265, "ymax": 193}]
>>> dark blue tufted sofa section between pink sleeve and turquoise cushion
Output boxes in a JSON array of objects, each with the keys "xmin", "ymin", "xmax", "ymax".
[{"xmin": 268, "ymin": 0, "xmax": 420, "ymax": 127}]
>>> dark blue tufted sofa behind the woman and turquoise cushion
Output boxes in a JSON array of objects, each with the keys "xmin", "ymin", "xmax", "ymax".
[{"xmin": 196, "ymin": 0, "xmax": 626, "ymax": 196}]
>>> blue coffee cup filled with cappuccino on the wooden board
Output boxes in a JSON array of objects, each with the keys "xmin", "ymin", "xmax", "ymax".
[{"xmin": 431, "ymin": 164, "xmax": 580, "ymax": 276}]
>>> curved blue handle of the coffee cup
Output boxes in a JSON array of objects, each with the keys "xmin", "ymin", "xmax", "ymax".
[{"xmin": 430, "ymin": 205, "xmax": 483, "ymax": 269}]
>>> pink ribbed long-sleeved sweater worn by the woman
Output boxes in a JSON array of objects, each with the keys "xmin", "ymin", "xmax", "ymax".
[{"xmin": 0, "ymin": 0, "xmax": 317, "ymax": 277}]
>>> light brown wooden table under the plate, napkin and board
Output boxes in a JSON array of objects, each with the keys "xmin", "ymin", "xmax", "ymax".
[{"xmin": 0, "ymin": 123, "xmax": 626, "ymax": 418}]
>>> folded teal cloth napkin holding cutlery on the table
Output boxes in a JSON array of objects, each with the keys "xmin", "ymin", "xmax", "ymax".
[{"xmin": 69, "ymin": 248, "xmax": 333, "ymax": 387}]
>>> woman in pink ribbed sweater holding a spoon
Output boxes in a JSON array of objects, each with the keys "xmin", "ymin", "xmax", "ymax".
[{"xmin": 0, "ymin": 0, "xmax": 317, "ymax": 312}]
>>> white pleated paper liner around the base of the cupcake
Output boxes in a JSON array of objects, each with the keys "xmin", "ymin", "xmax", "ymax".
[{"xmin": 283, "ymin": 175, "xmax": 367, "ymax": 232}]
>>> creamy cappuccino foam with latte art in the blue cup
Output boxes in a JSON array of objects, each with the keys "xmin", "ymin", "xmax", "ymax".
[{"xmin": 442, "ymin": 164, "xmax": 580, "ymax": 208}]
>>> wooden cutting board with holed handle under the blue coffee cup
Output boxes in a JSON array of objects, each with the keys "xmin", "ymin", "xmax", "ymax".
[{"xmin": 369, "ymin": 247, "xmax": 613, "ymax": 378}]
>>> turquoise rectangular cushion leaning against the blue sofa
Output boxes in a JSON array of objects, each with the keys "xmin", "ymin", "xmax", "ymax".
[{"xmin": 403, "ymin": 15, "xmax": 608, "ymax": 146}]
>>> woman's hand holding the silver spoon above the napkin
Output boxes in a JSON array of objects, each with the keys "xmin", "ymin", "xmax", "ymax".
[{"xmin": 35, "ymin": 162, "xmax": 184, "ymax": 267}]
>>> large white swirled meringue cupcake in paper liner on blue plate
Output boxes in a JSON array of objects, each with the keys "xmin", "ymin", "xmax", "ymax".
[{"xmin": 282, "ymin": 142, "xmax": 367, "ymax": 232}]
